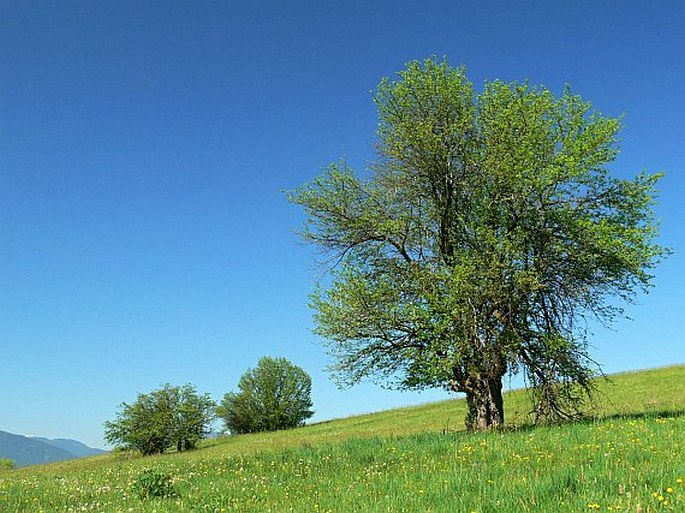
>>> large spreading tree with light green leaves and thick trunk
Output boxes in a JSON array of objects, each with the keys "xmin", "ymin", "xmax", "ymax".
[{"xmin": 290, "ymin": 59, "xmax": 666, "ymax": 429}]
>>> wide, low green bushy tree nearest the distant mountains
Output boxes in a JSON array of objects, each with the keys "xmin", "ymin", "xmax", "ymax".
[{"xmin": 105, "ymin": 384, "xmax": 216, "ymax": 455}]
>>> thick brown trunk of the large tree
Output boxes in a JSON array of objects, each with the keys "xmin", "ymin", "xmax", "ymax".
[{"xmin": 464, "ymin": 375, "xmax": 504, "ymax": 431}]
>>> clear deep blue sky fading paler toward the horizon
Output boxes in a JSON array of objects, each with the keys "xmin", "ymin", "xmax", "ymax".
[{"xmin": 0, "ymin": 0, "xmax": 685, "ymax": 445}]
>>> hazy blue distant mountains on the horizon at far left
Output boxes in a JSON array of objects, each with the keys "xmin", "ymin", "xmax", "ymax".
[{"xmin": 0, "ymin": 431, "xmax": 105, "ymax": 467}]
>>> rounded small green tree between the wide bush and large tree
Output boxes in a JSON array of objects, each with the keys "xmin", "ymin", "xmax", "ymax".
[{"xmin": 217, "ymin": 357, "xmax": 314, "ymax": 433}]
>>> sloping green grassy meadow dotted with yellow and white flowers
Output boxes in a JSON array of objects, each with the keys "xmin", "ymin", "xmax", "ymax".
[{"xmin": 0, "ymin": 365, "xmax": 685, "ymax": 513}]
